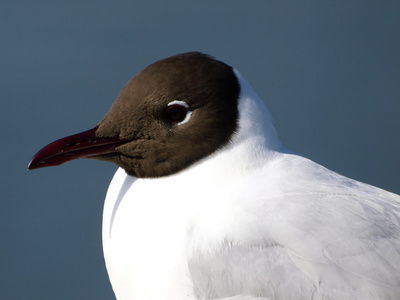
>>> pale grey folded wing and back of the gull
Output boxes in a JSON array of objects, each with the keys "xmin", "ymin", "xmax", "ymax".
[{"xmin": 189, "ymin": 158, "xmax": 400, "ymax": 299}]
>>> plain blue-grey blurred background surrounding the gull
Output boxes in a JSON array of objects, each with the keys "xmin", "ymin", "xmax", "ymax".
[{"xmin": 0, "ymin": 0, "xmax": 400, "ymax": 300}]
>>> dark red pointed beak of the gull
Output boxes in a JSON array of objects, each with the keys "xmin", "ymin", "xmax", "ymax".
[{"xmin": 28, "ymin": 127, "xmax": 127, "ymax": 170}]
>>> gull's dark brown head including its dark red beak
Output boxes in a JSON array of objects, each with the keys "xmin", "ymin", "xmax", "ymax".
[{"xmin": 28, "ymin": 52, "xmax": 240, "ymax": 177}]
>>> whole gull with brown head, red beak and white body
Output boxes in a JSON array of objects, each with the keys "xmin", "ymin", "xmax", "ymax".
[{"xmin": 28, "ymin": 52, "xmax": 400, "ymax": 300}]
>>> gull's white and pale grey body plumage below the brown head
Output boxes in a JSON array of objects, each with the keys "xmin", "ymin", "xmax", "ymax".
[{"xmin": 103, "ymin": 72, "xmax": 400, "ymax": 300}]
